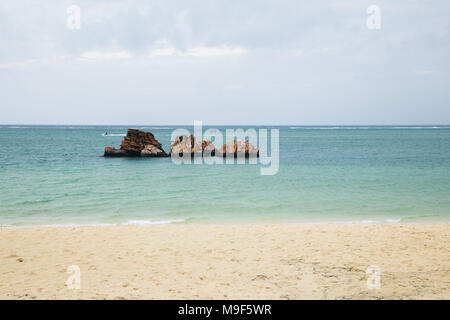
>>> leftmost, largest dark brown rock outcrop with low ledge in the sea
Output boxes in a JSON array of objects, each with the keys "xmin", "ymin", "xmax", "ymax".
[{"xmin": 104, "ymin": 129, "xmax": 167, "ymax": 157}]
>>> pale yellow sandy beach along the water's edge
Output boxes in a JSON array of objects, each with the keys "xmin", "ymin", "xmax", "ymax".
[{"xmin": 0, "ymin": 224, "xmax": 450, "ymax": 299}]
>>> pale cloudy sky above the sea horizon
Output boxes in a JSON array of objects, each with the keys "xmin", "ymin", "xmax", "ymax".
[{"xmin": 0, "ymin": 0, "xmax": 450, "ymax": 125}]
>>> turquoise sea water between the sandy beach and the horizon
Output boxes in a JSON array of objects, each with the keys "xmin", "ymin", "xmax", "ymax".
[{"xmin": 0, "ymin": 126, "xmax": 450, "ymax": 226}]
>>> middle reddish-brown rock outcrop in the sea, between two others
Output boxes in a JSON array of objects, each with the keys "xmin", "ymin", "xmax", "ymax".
[{"xmin": 170, "ymin": 134, "xmax": 216, "ymax": 156}]
